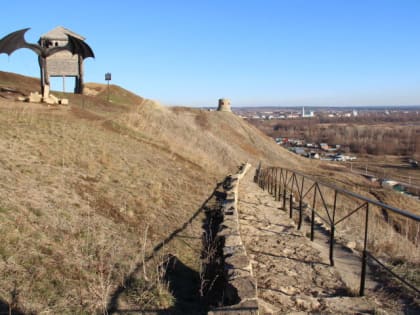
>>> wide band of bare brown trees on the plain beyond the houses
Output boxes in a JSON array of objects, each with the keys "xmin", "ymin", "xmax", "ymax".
[{"xmin": 251, "ymin": 112, "xmax": 420, "ymax": 158}]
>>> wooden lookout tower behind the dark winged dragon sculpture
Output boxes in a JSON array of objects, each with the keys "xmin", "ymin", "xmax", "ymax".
[{"xmin": 39, "ymin": 26, "xmax": 85, "ymax": 94}]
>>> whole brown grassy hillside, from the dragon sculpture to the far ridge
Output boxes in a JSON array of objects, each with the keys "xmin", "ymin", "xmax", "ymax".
[{"xmin": 0, "ymin": 72, "xmax": 414, "ymax": 314}]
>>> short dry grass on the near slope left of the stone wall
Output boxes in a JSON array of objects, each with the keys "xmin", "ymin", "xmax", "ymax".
[{"xmin": 0, "ymin": 104, "xmax": 212, "ymax": 313}]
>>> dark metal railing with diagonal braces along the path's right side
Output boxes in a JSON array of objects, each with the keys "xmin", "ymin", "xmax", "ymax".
[{"xmin": 254, "ymin": 165, "xmax": 420, "ymax": 296}]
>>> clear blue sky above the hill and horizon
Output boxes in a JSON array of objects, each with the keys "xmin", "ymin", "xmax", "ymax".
[{"xmin": 0, "ymin": 0, "xmax": 420, "ymax": 106}]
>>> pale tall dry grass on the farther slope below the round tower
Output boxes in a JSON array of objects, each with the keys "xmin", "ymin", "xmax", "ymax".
[{"xmin": 118, "ymin": 105, "xmax": 298, "ymax": 173}]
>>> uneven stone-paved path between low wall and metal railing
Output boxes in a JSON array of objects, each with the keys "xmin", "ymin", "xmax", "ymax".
[{"xmin": 238, "ymin": 171, "xmax": 388, "ymax": 314}]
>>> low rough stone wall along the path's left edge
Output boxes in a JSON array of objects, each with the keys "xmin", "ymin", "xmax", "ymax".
[{"xmin": 208, "ymin": 163, "xmax": 258, "ymax": 315}]
